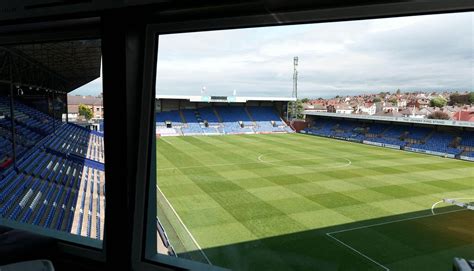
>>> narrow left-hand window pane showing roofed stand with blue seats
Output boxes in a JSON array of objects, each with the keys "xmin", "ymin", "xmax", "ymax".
[{"xmin": 0, "ymin": 40, "xmax": 105, "ymax": 245}]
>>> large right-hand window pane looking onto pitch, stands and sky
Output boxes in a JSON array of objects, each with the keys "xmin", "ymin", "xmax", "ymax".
[{"xmin": 152, "ymin": 12, "xmax": 474, "ymax": 270}]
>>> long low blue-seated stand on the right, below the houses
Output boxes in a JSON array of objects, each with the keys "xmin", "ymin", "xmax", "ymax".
[{"xmin": 303, "ymin": 118, "xmax": 474, "ymax": 158}]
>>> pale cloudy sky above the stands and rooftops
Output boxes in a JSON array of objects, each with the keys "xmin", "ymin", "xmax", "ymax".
[{"xmin": 73, "ymin": 12, "xmax": 474, "ymax": 98}]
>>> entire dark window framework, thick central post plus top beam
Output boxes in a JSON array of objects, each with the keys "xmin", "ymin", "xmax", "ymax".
[{"xmin": 0, "ymin": 0, "xmax": 474, "ymax": 270}]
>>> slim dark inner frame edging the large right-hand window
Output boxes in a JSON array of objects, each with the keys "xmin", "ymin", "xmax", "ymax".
[{"xmin": 132, "ymin": 2, "xmax": 474, "ymax": 270}]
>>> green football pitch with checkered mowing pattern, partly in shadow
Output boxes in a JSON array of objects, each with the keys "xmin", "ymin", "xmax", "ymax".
[{"xmin": 157, "ymin": 134, "xmax": 474, "ymax": 270}]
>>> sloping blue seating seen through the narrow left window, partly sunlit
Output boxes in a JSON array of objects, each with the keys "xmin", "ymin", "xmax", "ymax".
[{"xmin": 0, "ymin": 98, "xmax": 105, "ymax": 239}]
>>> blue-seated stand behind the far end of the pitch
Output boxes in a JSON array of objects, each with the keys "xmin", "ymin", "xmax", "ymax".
[{"xmin": 156, "ymin": 105, "xmax": 293, "ymax": 135}]
